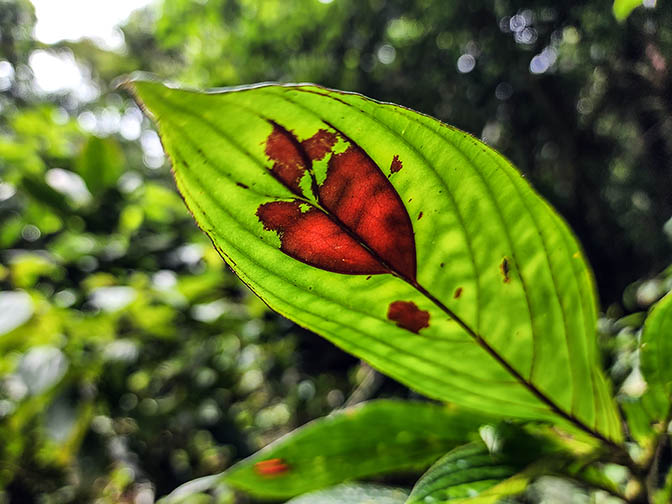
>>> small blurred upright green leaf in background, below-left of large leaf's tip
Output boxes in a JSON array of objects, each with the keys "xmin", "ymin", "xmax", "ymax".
[{"xmin": 76, "ymin": 135, "xmax": 126, "ymax": 195}]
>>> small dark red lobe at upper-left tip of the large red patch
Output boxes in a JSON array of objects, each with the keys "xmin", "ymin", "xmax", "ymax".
[{"xmin": 265, "ymin": 124, "xmax": 308, "ymax": 194}]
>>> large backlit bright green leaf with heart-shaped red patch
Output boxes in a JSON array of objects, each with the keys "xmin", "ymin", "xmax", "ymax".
[{"xmin": 129, "ymin": 82, "xmax": 621, "ymax": 441}]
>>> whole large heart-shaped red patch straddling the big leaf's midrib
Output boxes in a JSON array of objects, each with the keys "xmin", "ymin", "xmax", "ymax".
[{"xmin": 257, "ymin": 124, "xmax": 416, "ymax": 282}]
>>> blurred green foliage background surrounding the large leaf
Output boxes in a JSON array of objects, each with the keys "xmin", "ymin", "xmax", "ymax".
[{"xmin": 0, "ymin": 0, "xmax": 672, "ymax": 503}]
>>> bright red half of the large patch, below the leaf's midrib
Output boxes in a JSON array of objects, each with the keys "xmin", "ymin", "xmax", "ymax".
[{"xmin": 257, "ymin": 200, "xmax": 388, "ymax": 275}]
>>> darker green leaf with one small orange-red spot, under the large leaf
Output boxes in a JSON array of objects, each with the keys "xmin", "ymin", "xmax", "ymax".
[{"xmin": 224, "ymin": 400, "xmax": 487, "ymax": 497}]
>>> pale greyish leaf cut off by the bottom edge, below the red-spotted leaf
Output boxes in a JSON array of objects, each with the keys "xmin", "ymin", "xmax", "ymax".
[{"xmin": 287, "ymin": 483, "xmax": 408, "ymax": 504}]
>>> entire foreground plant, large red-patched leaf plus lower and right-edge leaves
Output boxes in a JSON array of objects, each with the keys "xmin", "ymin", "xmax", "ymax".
[{"xmin": 128, "ymin": 81, "xmax": 672, "ymax": 503}]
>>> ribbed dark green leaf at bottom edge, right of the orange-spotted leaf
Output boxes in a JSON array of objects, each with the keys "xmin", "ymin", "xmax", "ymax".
[{"xmin": 406, "ymin": 442, "xmax": 529, "ymax": 504}]
